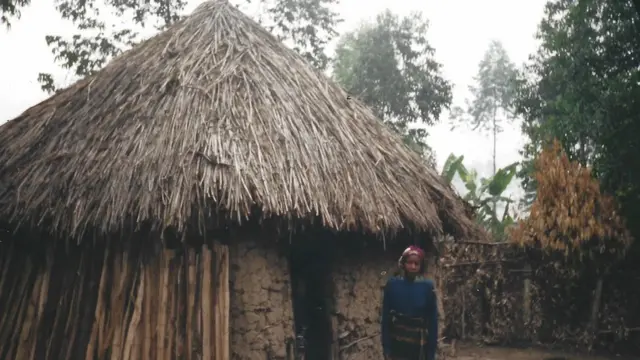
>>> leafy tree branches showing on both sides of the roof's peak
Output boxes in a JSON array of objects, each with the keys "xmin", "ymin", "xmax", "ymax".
[{"xmin": 38, "ymin": 0, "xmax": 340, "ymax": 92}]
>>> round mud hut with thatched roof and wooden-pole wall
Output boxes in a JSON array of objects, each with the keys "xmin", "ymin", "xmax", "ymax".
[{"xmin": 0, "ymin": 1, "xmax": 476, "ymax": 360}]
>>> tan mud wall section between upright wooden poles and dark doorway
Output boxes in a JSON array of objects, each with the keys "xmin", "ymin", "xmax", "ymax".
[{"xmin": 229, "ymin": 239, "xmax": 294, "ymax": 360}]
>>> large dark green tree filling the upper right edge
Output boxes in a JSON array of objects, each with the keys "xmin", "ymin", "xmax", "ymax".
[{"xmin": 516, "ymin": 0, "xmax": 640, "ymax": 239}]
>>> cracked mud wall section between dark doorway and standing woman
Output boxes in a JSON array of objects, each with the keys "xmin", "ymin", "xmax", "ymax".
[{"xmin": 332, "ymin": 252, "xmax": 398, "ymax": 360}]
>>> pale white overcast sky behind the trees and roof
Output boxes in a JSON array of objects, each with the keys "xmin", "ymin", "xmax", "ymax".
[{"xmin": 0, "ymin": 0, "xmax": 546, "ymax": 210}]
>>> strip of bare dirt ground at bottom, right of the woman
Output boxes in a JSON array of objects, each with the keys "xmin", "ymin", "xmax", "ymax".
[{"xmin": 447, "ymin": 345, "xmax": 640, "ymax": 360}]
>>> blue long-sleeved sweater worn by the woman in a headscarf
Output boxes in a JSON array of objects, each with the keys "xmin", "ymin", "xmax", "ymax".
[{"xmin": 382, "ymin": 277, "xmax": 438, "ymax": 360}]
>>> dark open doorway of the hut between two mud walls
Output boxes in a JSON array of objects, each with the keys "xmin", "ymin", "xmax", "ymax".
[{"xmin": 289, "ymin": 239, "xmax": 333, "ymax": 360}]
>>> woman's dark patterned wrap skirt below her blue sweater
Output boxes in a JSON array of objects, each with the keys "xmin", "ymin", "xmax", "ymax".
[{"xmin": 389, "ymin": 311, "xmax": 427, "ymax": 360}]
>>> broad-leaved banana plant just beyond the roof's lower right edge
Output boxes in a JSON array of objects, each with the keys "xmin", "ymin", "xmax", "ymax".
[{"xmin": 441, "ymin": 154, "xmax": 518, "ymax": 241}]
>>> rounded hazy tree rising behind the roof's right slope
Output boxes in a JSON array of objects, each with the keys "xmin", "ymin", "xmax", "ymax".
[{"xmin": 333, "ymin": 11, "xmax": 452, "ymax": 166}]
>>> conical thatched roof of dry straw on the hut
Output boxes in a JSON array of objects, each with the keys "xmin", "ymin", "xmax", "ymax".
[{"xmin": 0, "ymin": 1, "xmax": 476, "ymax": 242}]
